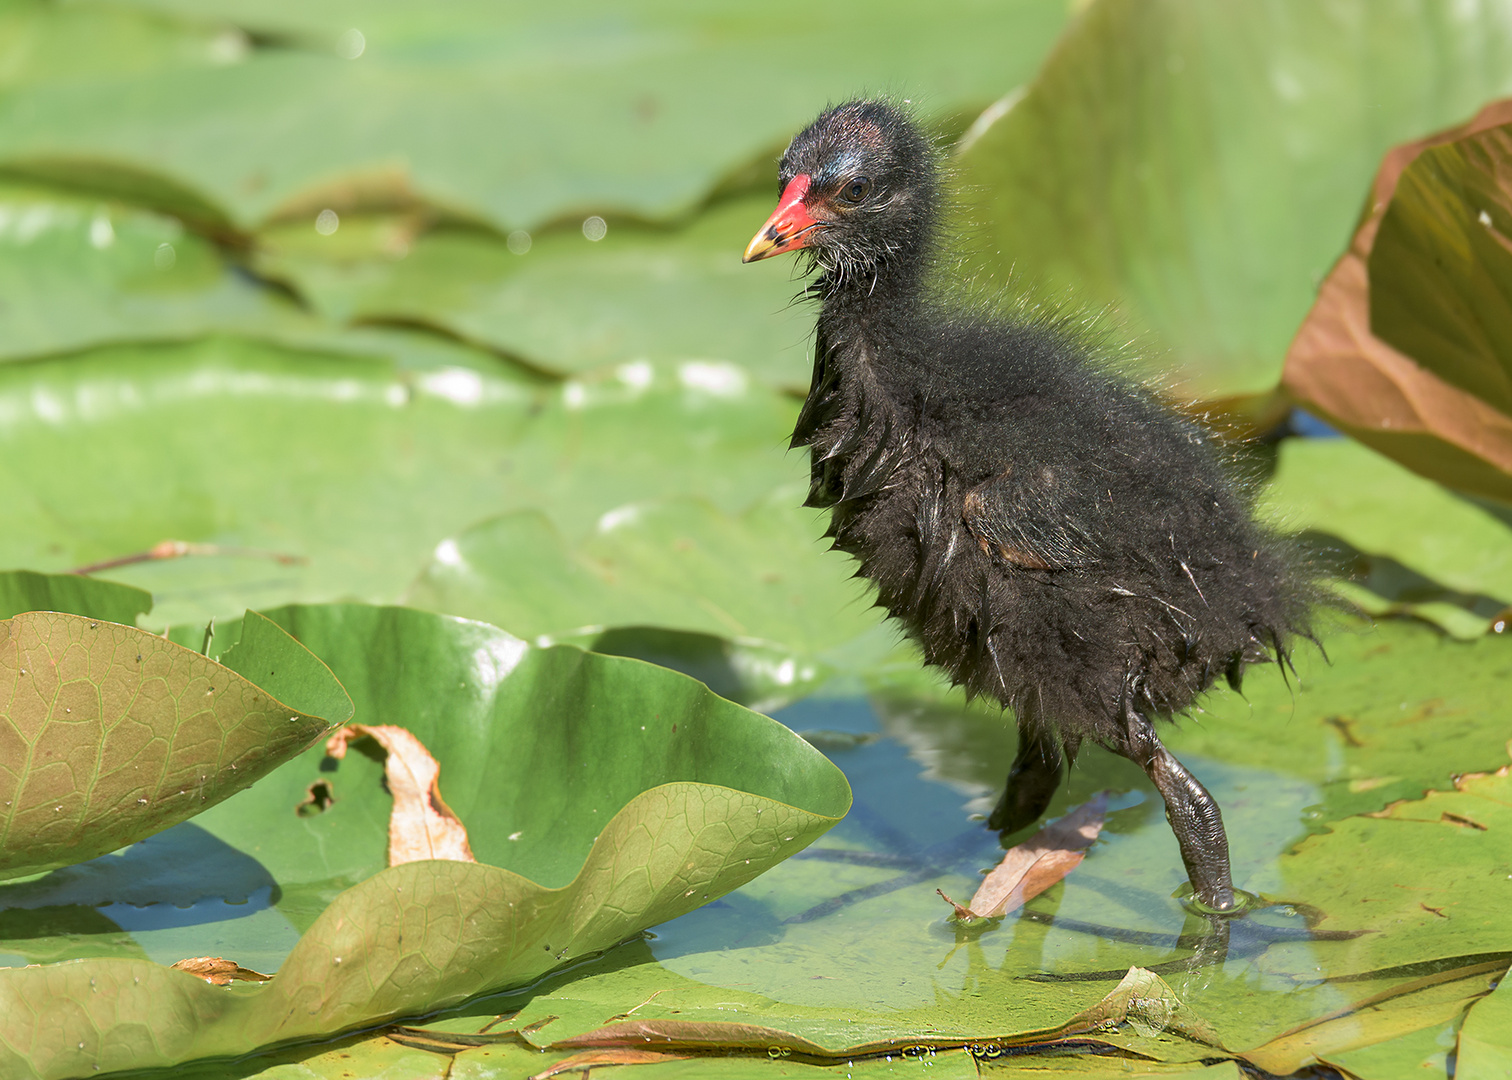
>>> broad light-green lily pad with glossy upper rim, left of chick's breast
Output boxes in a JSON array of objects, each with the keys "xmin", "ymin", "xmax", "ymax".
[{"xmin": 0, "ymin": 339, "xmax": 804, "ymax": 626}]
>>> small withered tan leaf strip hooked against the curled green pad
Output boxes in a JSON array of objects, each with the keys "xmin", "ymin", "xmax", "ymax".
[{"xmin": 325, "ymin": 723, "xmax": 476, "ymax": 867}]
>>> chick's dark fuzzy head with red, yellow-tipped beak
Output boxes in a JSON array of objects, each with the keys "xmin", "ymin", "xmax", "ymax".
[{"xmin": 745, "ymin": 101, "xmax": 939, "ymax": 280}]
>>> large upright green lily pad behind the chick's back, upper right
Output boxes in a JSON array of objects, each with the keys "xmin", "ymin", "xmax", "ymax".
[{"xmin": 960, "ymin": 0, "xmax": 1512, "ymax": 399}]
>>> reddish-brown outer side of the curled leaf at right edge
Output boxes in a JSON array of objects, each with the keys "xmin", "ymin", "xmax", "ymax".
[{"xmin": 1282, "ymin": 100, "xmax": 1512, "ymax": 499}]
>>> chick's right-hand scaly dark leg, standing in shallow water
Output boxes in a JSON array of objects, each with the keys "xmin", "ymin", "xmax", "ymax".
[{"xmin": 1111, "ymin": 699, "xmax": 1234, "ymax": 911}]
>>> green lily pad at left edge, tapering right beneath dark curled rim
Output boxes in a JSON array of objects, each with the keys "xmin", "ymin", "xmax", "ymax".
[{"xmin": 0, "ymin": 178, "xmax": 305, "ymax": 360}]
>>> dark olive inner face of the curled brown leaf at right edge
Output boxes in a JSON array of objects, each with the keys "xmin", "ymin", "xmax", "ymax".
[{"xmin": 1370, "ymin": 126, "xmax": 1512, "ymax": 413}]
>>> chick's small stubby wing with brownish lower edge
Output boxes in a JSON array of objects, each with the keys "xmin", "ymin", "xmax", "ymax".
[{"xmin": 962, "ymin": 466, "xmax": 1098, "ymax": 570}]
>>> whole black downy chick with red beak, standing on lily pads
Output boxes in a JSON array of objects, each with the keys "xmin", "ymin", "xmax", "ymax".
[{"xmin": 745, "ymin": 101, "xmax": 1312, "ymax": 912}]
